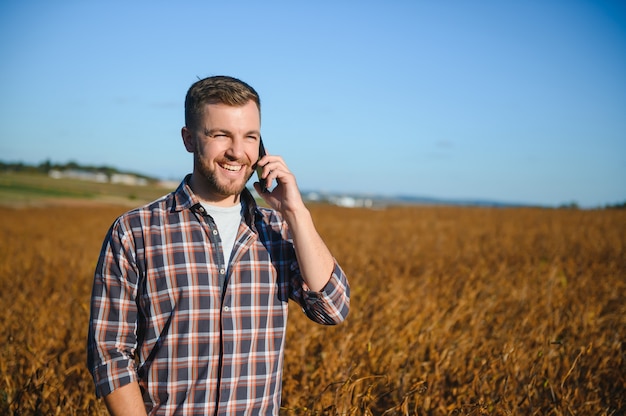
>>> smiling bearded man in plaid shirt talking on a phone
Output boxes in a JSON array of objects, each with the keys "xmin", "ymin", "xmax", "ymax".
[{"xmin": 88, "ymin": 76, "xmax": 350, "ymax": 415}]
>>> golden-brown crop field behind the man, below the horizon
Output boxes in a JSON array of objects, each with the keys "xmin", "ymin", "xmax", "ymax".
[{"xmin": 0, "ymin": 194, "xmax": 626, "ymax": 415}]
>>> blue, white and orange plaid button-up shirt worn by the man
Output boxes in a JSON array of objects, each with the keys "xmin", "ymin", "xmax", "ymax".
[{"xmin": 88, "ymin": 178, "xmax": 350, "ymax": 415}]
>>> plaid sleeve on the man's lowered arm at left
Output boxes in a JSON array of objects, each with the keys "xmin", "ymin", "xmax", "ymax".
[{"xmin": 87, "ymin": 219, "xmax": 139, "ymax": 397}]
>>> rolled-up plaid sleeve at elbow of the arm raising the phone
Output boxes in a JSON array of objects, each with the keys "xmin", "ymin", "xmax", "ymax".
[{"xmin": 292, "ymin": 260, "xmax": 350, "ymax": 325}]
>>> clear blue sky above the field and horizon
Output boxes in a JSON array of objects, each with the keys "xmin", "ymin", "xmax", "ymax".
[{"xmin": 0, "ymin": 0, "xmax": 626, "ymax": 207}]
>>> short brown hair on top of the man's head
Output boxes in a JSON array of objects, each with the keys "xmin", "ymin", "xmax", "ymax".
[{"xmin": 185, "ymin": 75, "xmax": 261, "ymax": 128}]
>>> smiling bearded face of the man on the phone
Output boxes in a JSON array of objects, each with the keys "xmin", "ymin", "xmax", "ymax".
[{"xmin": 183, "ymin": 101, "xmax": 261, "ymax": 202}]
